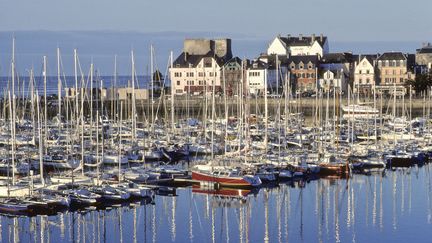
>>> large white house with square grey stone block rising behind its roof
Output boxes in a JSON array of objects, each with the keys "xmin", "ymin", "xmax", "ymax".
[{"xmin": 169, "ymin": 39, "xmax": 232, "ymax": 95}]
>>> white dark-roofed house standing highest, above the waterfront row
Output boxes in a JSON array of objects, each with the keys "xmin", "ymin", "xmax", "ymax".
[{"xmin": 267, "ymin": 34, "xmax": 329, "ymax": 57}]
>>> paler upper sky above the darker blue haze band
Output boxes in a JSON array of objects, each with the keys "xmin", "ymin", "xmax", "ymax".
[{"xmin": 0, "ymin": 0, "xmax": 432, "ymax": 41}]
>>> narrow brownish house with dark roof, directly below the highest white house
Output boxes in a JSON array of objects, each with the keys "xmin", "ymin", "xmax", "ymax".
[{"xmin": 287, "ymin": 55, "xmax": 319, "ymax": 92}]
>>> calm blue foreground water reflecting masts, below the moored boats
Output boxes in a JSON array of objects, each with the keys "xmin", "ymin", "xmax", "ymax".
[{"xmin": 0, "ymin": 164, "xmax": 432, "ymax": 242}]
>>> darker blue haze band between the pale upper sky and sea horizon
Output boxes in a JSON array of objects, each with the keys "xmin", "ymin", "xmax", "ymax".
[{"xmin": 0, "ymin": 31, "xmax": 420, "ymax": 76}]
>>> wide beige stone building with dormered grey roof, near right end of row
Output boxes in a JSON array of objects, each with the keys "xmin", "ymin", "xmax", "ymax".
[{"xmin": 377, "ymin": 52, "xmax": 415, "ymax": 86}]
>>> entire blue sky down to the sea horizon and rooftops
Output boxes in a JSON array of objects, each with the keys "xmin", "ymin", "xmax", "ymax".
[{"xmin": 0, "ymin": 0, "xmax": 432, "ymax": 76}]
